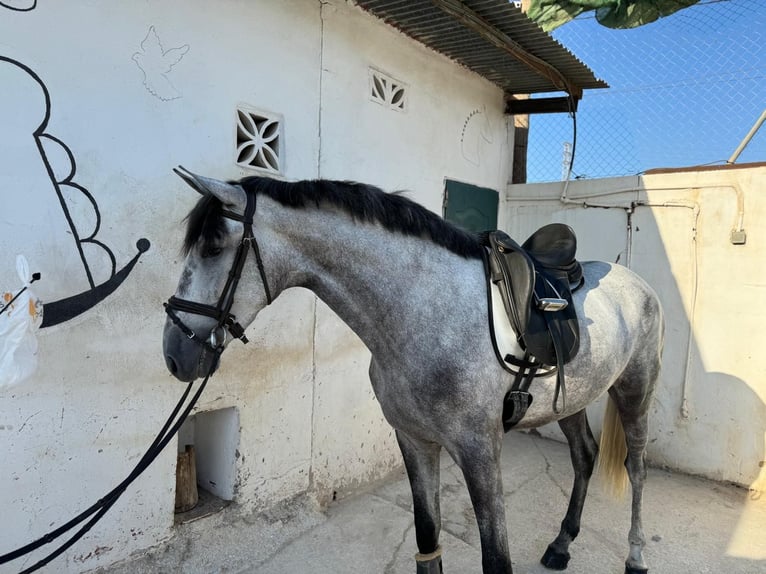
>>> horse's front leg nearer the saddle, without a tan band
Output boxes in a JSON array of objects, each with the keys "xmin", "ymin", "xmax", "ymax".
[{"xmin": 450, "ymin": 429, "xmax": 513, "ymax": 574}]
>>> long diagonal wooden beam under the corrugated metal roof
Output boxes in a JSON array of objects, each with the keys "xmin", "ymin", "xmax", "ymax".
[{"xmin": 431, "ymin": 0, "xmax": 582, "ymax": 99}]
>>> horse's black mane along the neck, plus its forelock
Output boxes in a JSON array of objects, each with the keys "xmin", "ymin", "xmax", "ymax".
[{"xmin": 183, "ymin": 176, "xmax": 483, "ymax": 258}]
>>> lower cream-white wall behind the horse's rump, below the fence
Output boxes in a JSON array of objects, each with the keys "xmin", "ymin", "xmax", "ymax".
[{"xmin": 501, "ymin": 166, "xmax": 766, "ymax": 491}]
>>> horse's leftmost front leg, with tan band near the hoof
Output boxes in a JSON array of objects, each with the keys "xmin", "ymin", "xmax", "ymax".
[{"xmin": 396, "ymin": 431, "xmax": 442, "ymax": 574}]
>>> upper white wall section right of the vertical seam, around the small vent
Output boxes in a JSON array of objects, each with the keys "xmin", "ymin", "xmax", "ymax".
[{"xmin": 320, "ymin": 1, "xmax": 512, "ymax": 208}]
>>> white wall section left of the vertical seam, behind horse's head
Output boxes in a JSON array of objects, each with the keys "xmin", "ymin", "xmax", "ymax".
[{"xmin": 0, "ymin": 1, "xmax": 321, "ymax": 572}]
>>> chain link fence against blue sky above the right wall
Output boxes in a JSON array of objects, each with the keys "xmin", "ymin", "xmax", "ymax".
[{"xmin": 527, "ymin": 0, "xmax": 766, "ymax": 182}]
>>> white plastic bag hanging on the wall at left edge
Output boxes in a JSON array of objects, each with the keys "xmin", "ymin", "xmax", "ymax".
[{"xmin": 0, "ymin": 255, "xmax": 43, "ymax": 388}]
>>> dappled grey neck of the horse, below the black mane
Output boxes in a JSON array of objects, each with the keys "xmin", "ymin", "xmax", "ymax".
[{"xmin": 268, "ymin": 200, "xmax": 486, "ymax": 353}]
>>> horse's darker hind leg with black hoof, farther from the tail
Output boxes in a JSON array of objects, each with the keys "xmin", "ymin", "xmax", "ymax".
[{"xmin": 540, "ymin": 410, "xmax": 598, "ymax": 570}]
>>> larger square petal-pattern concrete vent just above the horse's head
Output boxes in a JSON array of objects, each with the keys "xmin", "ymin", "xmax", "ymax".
[{"xmin": 236, "ymin": 106, "xmax": 283, "ymax": 173}]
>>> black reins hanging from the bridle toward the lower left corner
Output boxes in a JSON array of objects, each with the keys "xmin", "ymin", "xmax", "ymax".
[{"xmin": 0, "ymin": 363, "xmax": 215, "ymax": 574}]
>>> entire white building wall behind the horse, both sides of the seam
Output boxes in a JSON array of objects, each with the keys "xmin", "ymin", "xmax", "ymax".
[{"xmin": 0, "ymin": 0, "xmax": 509, "ymax": 572}]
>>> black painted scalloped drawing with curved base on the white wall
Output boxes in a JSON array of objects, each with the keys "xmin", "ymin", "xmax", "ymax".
[{"xmin": 0, "ymin": 55, "xmax": 150, "ymax": 327}]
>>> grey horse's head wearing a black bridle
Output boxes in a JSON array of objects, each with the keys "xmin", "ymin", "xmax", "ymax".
[{"xmin": 163, "ymin": 168, "xmax": 271, "ymax": 382}]
